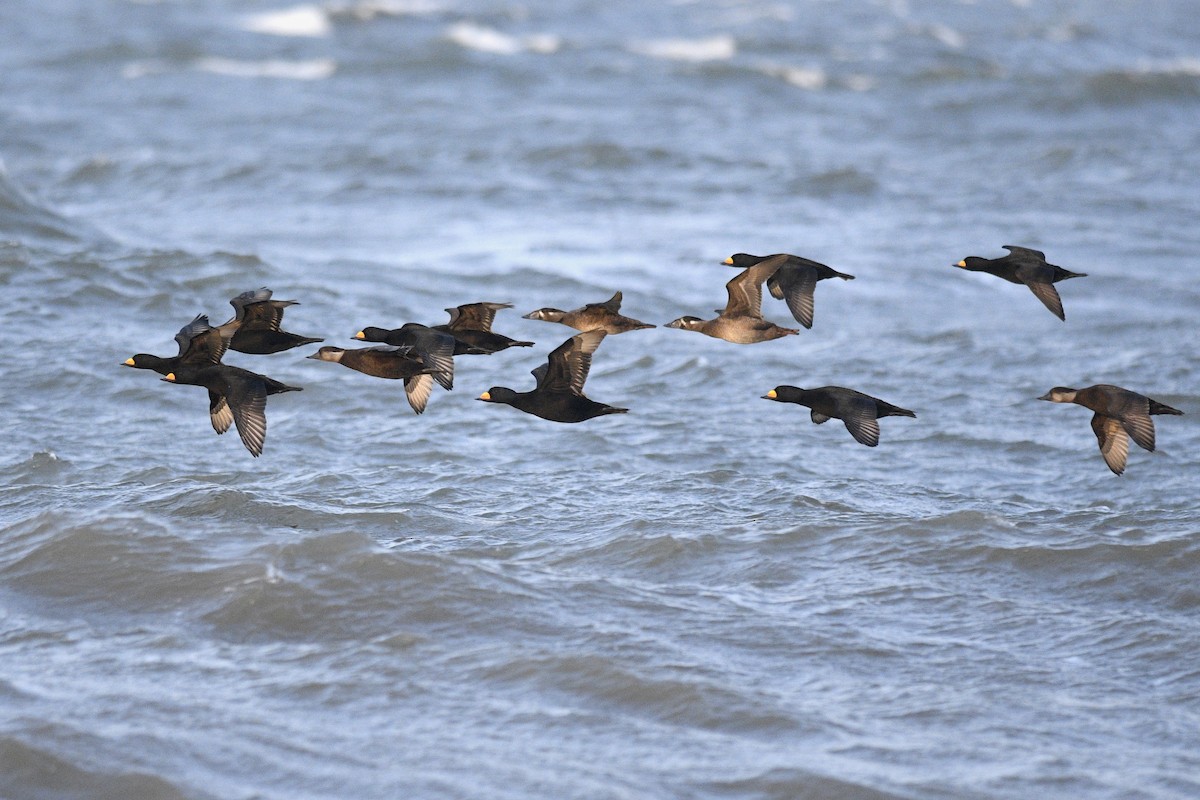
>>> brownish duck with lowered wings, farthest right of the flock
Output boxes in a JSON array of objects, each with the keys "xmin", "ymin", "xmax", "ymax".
[{"xmin": 1038, "ymin": 384, "xmax": 1183, "ymax": 475}]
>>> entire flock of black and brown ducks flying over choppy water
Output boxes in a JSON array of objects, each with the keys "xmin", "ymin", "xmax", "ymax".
[{"xmin": 124, "ymin": 245, "xmax": 1183, "ymax": 475}]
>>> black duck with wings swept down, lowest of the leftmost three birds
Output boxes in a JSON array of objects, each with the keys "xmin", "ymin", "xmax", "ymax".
[{"xmin": 163, "ymin": 363, "xmax": 300, "ymax": 458}]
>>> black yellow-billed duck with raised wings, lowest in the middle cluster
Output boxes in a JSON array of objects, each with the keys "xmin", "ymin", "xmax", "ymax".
[{"xmin": 479, "ymin": 330, "xmax": 629, "ymax": 422}]
